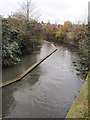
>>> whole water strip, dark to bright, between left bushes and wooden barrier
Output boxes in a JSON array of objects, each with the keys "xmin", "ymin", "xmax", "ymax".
[{"xmin": 2, "ymin": 42, "xmax": 54, "ymax": 81}]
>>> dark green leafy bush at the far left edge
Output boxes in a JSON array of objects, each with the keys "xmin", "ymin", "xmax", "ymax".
[{"xmin": 2, "ymin": 19, "xmax": 21, "ymax": 66}]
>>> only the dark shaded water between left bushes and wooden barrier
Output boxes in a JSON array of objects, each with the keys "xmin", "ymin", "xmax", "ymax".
[{"xmin": 2, "ymin": 47, "xmax": 41, "ymax": 81}]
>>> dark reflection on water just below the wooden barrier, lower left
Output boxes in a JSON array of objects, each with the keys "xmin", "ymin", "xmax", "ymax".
[{"xmin": 2, "ymin": 65, "xmax": 41, "ymax": 117}]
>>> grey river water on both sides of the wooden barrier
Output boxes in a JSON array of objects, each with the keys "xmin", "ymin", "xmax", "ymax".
[{"xmin": 2, "ymin": 42, "xmax": 83, "ymax": 118}]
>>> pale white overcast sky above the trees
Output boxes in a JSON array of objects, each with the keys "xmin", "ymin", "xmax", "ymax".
[{"xmin": 0, "ymin": 0, "xmax": 90, "ymax": 24}]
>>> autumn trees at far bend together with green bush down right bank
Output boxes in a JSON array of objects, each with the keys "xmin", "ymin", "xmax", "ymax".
[{"xmin": 43, "ymin": 21, "xmax": 90, "ymax": 76}]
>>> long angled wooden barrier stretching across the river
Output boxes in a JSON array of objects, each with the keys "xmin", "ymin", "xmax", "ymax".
[{"xmin": 0, "ymin": 46, "xmax": 57, "ymax": 88}]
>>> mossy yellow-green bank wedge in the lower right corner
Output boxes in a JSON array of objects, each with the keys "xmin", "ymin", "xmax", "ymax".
[{"xmin": 65, "ymin": 75, "xmax": 90, "ymax": 120}]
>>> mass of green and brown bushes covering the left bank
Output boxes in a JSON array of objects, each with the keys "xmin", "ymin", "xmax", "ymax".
[{"xmin": 2, "ymin": 17, "xmax": 42, "ymax": 66}]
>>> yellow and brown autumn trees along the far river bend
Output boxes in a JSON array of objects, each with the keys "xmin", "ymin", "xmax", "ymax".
[{"xmin": 42, "ymin": 21, "xmax": 86, "ymax": 47}]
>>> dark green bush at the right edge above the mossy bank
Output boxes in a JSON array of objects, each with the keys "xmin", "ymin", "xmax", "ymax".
[{"xmin": 79, "ymin": 26, "xmax": 90, "ymax": 77}]
